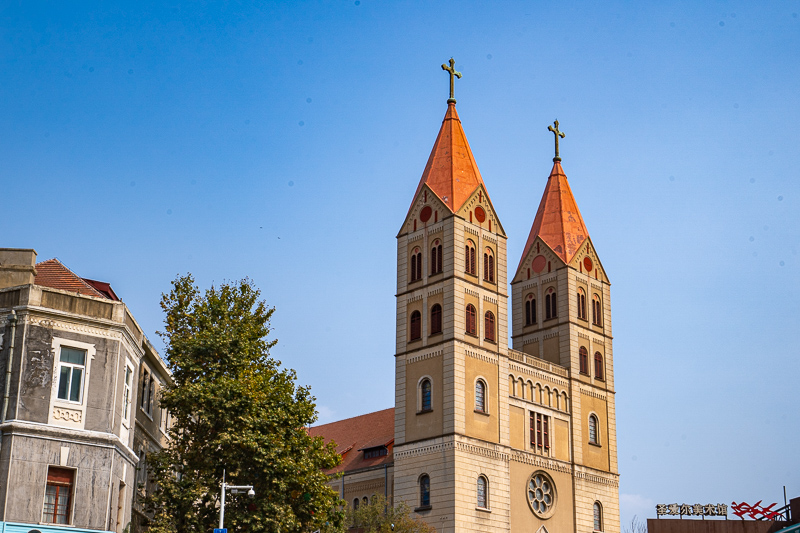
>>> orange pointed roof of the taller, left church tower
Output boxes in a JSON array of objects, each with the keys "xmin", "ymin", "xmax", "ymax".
[{"xmin": 414, "ymin": 102, "xmax": 483, "ymax": 213}]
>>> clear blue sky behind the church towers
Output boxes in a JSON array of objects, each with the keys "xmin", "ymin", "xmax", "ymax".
[{"xmin": 0, "ymin": 0, "xmax": 800, "ymax": 522}]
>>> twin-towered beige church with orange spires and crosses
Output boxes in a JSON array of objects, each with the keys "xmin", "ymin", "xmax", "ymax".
[{"xmin": 311, "ymin": 59, "xmax": 620, "ymax": 533}]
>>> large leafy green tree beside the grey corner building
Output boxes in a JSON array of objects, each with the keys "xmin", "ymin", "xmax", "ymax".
[{"xmin": 147, "ymin": 275, "xmax": 344, "ymax": 533}]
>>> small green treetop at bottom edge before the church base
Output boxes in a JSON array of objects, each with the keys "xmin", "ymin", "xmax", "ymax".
[{"xmin": 330, "ymin": 496, "xmax": 436, "ymax": 533}]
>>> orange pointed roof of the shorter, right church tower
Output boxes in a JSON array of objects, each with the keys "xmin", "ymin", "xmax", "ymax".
[{"xmin": 522, "ymin": 161, "xmax": 589, "ymax": 263}]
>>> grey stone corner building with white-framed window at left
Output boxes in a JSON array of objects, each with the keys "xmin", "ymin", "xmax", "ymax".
[{"xmin": 0, "ymin": 249, "xmax": 170, "ymax": 533}]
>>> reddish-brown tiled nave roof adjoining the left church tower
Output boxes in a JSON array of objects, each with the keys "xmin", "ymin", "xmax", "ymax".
[{"xmin": 308, "ymin": 407, "xmax": 394, "ymax": 474}]
